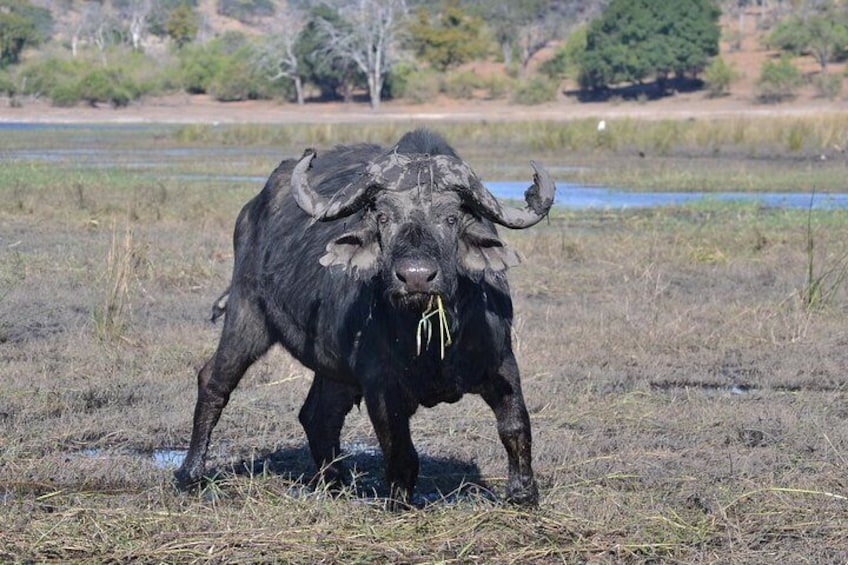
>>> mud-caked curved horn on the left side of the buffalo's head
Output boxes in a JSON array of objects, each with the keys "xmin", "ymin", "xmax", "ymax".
[{"xmin": 291, "ymin": 149, "xmax": 378, "ymax": 222}]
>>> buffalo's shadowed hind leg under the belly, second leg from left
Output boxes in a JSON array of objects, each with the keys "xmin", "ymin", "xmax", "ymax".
[{"xmin": 299, "ymin": 373, "xmax": 361, "ymax": 486}]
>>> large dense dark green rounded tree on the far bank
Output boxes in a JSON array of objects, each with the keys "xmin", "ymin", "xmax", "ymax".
[{"xmin": 580, "ymin": 0, "xmax": 720, "ymax": 89}]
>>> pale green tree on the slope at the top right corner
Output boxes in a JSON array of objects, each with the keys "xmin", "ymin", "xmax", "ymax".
[{"xmin": 768, "ymin": 4, "xmax": 848, "ymax": 73}]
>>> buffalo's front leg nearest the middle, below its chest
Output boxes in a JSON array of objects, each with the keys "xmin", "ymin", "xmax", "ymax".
[{"xmin": 365, "ymin": 385, "xmax": 419, "ymax": 508}]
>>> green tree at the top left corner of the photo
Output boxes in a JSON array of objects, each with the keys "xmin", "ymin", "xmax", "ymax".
[{"xmin": 0, "ymin": 0, "xmax": 52, "ymax": 68}]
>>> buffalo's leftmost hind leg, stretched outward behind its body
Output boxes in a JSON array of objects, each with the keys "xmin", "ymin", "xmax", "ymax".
[{"xmin": 174, "ymin": 298, "xmax": 271, "ymax": 488}]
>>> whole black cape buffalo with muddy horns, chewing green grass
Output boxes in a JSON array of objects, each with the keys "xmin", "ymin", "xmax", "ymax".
[{"xmin": 175, "ymin": 130, "xmax": 555, "ymax": 504}]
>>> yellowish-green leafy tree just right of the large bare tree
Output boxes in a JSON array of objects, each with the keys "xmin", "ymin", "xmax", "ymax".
[{"xmin": 409, "ymin": 2, "xmax": 488, "ymax": 71}]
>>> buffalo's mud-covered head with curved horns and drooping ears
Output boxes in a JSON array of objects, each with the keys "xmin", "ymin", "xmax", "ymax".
[{"xmin": 291, "ymin": 145, "xmax": 555, "ymax": 309}]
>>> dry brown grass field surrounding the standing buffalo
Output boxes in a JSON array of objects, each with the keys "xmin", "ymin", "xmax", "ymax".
[{"xmin": 0, "ymin": 118, "xmax": 848, "ymax": 564}]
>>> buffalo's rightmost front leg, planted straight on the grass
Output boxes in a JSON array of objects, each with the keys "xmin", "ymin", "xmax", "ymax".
[{"xmin": 482, "ymin": 356, "xmax": 539, "ymax": 505}]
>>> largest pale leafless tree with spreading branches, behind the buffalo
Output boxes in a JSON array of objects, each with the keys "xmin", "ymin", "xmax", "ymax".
[{"xmin": 321, "ymin": 0, "xmax": 408, "ymax": 110}]
